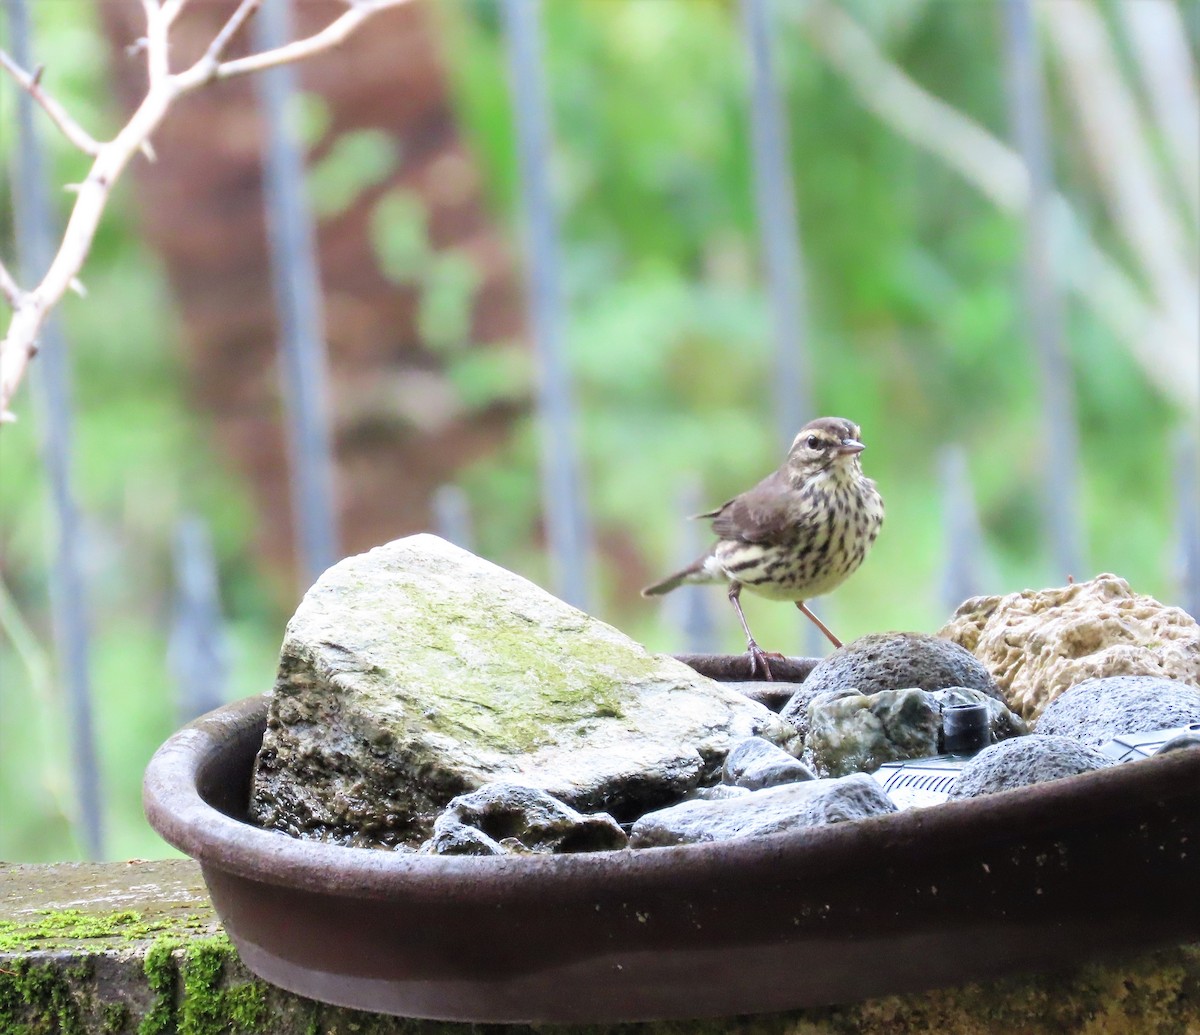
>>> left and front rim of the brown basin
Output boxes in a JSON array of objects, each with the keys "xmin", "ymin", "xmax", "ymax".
[{"xmin": 143, "ymin": 694, "xmax": 1200, "ymax": 899}]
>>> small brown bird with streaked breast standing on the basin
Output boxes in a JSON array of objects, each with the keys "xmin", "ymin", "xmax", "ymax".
[{"xmin": 642, "ymin": 417, "xmax": 883, "ymax": 680}]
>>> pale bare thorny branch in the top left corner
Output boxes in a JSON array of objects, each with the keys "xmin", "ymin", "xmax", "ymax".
[{"xmin": 0, "ymin": 0, "xmax": 408, "ymax": 423}]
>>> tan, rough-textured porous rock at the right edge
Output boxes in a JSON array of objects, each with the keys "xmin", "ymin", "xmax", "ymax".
[{"xmin": 937, "ymin": 575, "xmax": 1200, "ymax": 719}]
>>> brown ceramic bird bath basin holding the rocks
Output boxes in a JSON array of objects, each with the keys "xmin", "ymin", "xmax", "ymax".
[{"xmin": 144, "ymin": 677, "xmax": 1200, "ymax": 1022}]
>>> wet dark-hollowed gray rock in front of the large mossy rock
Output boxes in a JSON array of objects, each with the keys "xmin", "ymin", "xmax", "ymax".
[{"xmin": 422, "ymin": 780, "xmax": 629, "ymax": 855}]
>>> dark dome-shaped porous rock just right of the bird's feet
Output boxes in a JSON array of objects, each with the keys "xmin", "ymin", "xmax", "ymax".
[{"xmin": 780, "ymin": 633, "xmax": 1003, "ymax": 731}]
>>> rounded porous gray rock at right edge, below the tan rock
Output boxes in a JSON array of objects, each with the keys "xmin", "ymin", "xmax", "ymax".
[{"xmin": 1036, "ymin": 676, "xmax": 1200, "ymax": 747}]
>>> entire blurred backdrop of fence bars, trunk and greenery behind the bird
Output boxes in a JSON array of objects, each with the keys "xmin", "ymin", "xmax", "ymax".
[{"xmin": 0, "ymin": 0, "xmax": 1200, "ymax": 861}]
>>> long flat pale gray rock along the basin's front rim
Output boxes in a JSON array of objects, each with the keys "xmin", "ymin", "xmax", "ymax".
[{"xmin": 629, "ymin": 773, "xmax": 896, "ymax": 848}]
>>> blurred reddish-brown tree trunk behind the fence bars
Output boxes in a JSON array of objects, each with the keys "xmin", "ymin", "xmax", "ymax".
[{"xmin": 97, "ymin": 0, "xmax": 524, "ymax": 583}]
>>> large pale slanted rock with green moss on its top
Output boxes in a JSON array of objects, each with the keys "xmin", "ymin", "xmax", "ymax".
[{"xmin": 251, "ymin": 534, "xmax": 796, "ymax": 846}]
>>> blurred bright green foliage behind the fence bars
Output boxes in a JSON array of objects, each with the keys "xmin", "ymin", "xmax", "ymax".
[{"xmin": 0, "ymin": 0, "xmax": 1194, "ymax": 860}]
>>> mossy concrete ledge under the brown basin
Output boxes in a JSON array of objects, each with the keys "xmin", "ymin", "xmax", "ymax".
[{"xmin": 0, "ymin": 860, "xmax": 1200, "ymax": 1035}]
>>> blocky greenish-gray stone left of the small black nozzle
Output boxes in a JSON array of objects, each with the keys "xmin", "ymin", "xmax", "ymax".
[{"xmin": 803, "ymin": 689, "xmax": 942, "ymax": 777}]
